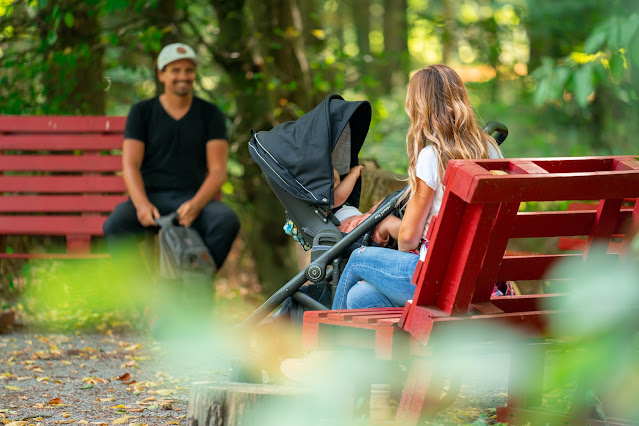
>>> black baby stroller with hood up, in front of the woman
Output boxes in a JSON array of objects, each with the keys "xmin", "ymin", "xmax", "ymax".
[{"xmin": 243, "ymin": 94, "xmax": 508, "ymax": 326}]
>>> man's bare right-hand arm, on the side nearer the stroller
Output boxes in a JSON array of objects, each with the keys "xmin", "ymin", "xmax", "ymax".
[{"xmin": 177, "ymin": 139, "xmax": 228, "ymax": 226}]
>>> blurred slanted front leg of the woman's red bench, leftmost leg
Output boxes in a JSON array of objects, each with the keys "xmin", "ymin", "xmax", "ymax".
[{"xmin": 395, "ymin": 359, "xmax": 443, "ymax": 425}]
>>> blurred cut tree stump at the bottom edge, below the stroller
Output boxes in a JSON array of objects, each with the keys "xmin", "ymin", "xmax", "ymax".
[{"xmin": 187, "ymin": 382, "xmax": 304, "ymax": 426}]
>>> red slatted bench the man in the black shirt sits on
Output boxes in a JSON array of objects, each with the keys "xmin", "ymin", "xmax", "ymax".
[{"xmin": 0, "ymin": 116, "xmax": 126, "ymax": 259}]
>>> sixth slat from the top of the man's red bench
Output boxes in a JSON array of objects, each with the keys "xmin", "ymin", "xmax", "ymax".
[{"xmin": 0, "ymin": 215, "xmax": 106, "ymax": 236}]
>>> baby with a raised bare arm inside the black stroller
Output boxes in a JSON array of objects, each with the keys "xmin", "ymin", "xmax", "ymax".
[{"xmin": 333, "ymin": 166, "xmax": 402, "ymax": 247}]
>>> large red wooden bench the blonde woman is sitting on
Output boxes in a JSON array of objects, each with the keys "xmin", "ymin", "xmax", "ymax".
[{"xmin": 302, "ymin": 156, "xmax": 639, "ymax": 424}]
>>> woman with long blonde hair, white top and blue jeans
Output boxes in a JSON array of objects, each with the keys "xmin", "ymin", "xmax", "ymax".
[{"xmin": 333, "ymin": 65, "xmax": 503, "ymax": 309}]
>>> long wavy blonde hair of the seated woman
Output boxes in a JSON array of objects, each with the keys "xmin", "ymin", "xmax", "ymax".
[{"xmin": 403, "ymin": 65, "xmax": 499, "ymax": 202}]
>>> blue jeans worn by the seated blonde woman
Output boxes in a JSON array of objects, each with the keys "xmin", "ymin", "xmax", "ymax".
[{"xmin": 333, "ymin": 247, "xmax": 419, "ymax": 309}]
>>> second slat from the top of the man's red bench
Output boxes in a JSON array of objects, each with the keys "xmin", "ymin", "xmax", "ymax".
[{"xmin": 0, "ymin": 134, "xmax": 122, "ymax": 151}]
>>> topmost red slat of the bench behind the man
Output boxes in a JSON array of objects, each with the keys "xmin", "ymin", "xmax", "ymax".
[{"xmin": 0, "ymin": 115, "xmax": 126, "ymax": 134}]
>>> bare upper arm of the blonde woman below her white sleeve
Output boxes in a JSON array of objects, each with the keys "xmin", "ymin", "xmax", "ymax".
[{"xmin": 397, "ymin": 179, "xmax": 435, "ymax": 251}]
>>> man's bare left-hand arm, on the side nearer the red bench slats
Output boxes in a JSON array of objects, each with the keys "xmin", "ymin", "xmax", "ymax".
[{"xmin": 122, "ymin": 139, "xmax": 160, "ymax": 226}]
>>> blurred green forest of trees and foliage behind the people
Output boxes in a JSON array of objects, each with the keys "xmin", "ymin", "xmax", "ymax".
[{"xmin": 0, "ymin": 0, "xmax": 639, "ymax": 320}]
